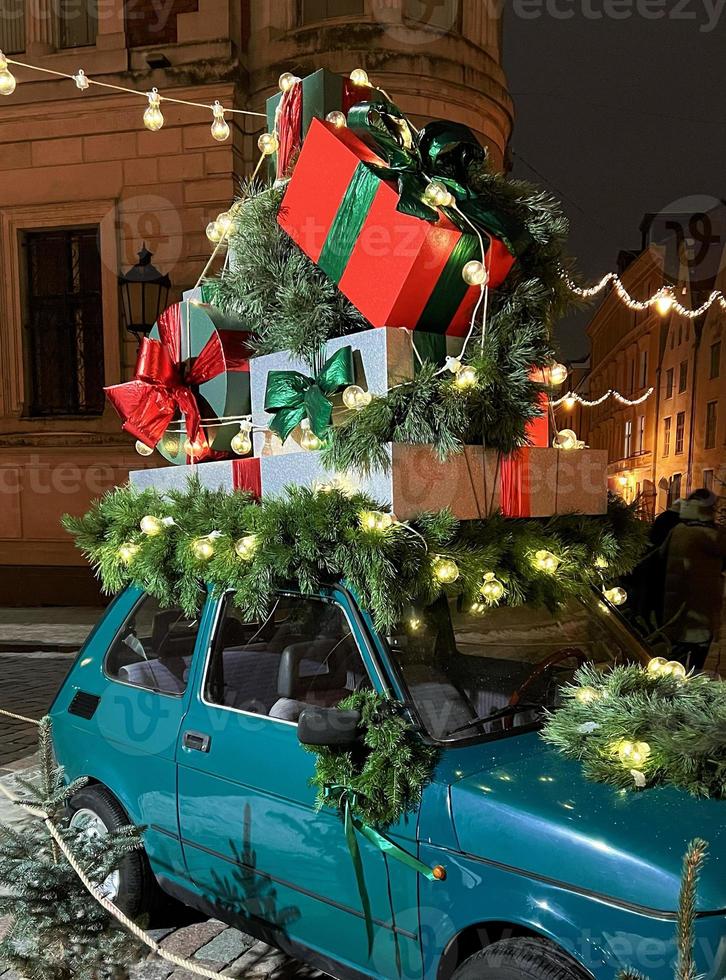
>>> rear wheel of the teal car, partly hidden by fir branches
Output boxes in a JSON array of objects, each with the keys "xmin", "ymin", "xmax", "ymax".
[{"xmin": 69, "ymin": 786, "xmax": 158, "ymax": 919}]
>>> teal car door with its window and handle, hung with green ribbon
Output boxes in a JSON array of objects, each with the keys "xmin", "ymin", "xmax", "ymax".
[{"xmin": 177, "ymin": 593, "xmax": 421, "ymax": 976}]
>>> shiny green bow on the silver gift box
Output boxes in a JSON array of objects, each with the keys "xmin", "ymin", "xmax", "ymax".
[{"xmin": 265, "ymin": 347, "xmax": 355, "ymax": 442}]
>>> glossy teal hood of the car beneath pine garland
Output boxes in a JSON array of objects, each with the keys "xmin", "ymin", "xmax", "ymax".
[{"xmin": 446, "ymin": 733, "xmax": 726, "ymax": 912}]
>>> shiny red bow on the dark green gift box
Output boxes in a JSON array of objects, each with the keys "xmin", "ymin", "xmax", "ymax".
[{"xmin": 105, "ymin": 305, "xmax": 226, "ymax": 458}]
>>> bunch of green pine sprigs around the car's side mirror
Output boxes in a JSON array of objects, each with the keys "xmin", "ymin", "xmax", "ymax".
[{"xmin": 308, "ymin": 691, "xmax": 437, "ymax": 828}]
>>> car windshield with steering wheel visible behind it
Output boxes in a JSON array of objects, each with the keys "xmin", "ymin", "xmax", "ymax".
[{"xmin": 386, "ymin": 598, "xmax": 650, "ymax": 741}]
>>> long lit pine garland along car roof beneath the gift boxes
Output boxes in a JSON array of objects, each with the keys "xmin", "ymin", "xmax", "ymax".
[{"xmin": 63, "ymin": 480, "xmax": 646, "ymax": 629}]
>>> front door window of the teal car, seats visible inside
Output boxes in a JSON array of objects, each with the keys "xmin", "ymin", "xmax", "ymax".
[{"xmin": 204, "ymin": 595, "xmax": 371, "ymax": 722}]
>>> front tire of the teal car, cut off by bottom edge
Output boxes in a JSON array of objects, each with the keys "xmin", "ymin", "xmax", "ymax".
[{"xmin": 451, "ymin": 938, "xmax": 587, "ymax": 980}]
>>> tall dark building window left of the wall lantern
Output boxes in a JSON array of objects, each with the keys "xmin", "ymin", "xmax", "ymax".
[{"xmin": 24, "ymin": 227, "xmax": 104, "ymax": 416}]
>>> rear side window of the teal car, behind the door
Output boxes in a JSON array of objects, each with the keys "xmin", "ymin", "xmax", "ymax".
[{"xmin": 105, "ymin": 596, "xmax": 199, "ymax": 695}]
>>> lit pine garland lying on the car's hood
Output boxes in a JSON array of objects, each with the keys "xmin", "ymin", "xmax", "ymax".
[{"xmin": 542, "ymin": 657, "xmax": 726, "ymax": 799}]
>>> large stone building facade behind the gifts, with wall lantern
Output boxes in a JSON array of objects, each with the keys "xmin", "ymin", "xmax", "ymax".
[{"xmin": 0, "ymin": 0, "xmax": 512, "ymax": 604}]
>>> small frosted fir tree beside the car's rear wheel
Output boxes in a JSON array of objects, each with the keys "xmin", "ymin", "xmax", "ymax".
[{"xmin": 0, "ymin": 718, "xmax": 141, "ymax": 980}]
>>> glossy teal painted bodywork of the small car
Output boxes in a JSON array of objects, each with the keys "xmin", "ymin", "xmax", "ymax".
[{"xmin": 51, "ymin": 587, "xmax": 726, "ymax": 980}]
